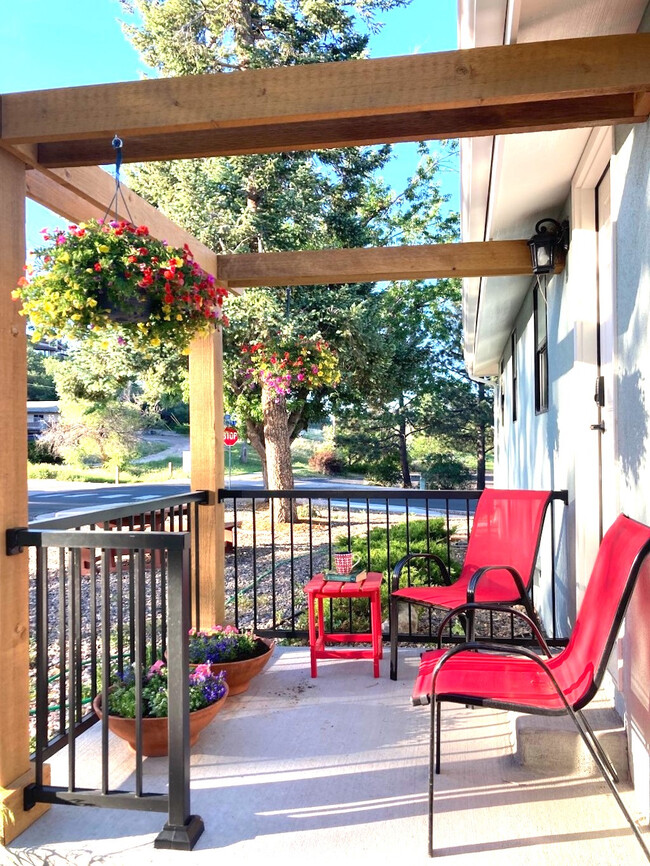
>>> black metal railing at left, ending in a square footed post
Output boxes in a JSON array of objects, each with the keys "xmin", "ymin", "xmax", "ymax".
[{"xmin": 7, "ymin": 492, "xmax": 206, "ymax": 848}]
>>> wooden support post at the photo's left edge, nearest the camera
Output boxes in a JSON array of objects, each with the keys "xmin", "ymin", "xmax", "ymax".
[{"xmin": 0, "ymin": 151, "xmax": 48, "ymax": 845}]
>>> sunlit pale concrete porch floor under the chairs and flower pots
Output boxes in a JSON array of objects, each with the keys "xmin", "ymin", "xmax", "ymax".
[{"xmin": 0, "ymin": 647, "xmax": 646, "ymax": 866}]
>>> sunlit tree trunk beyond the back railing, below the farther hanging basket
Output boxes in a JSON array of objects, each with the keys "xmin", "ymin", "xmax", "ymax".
[{"xmin": 262, "ymin": 384, "xmax": 296, "ymax": 523}]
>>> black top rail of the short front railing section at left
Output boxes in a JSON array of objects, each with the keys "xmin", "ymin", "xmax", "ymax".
[{"xmin": 7, "ymin": 528, "xmax": 191, "ymax": 555}]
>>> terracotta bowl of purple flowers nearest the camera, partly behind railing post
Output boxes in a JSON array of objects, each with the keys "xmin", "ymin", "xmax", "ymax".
[{"xmin": 93, "ymin": 660, "xmax": 228, "ymax": 757}]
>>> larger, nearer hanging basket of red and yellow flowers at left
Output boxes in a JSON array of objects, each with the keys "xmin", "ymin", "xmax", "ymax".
[{"xmin": 13, "ymin": 220, "xmax": 227, "ymax": 353}]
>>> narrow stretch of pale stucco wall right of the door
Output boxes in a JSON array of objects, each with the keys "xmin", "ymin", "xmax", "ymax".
[{"xmin": 612, "ymin": 113, "xmax": 650, "ymax": 814}]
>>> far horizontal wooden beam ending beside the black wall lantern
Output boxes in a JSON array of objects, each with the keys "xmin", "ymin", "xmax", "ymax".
[{"xmin": 217, "ymin": 240, "xmax": 532, "ymax": 288}]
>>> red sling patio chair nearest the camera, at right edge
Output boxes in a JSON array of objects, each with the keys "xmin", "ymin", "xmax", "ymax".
[{"xmin": 413, "ymin": 515, "xmax": 650, "ymax": 860}]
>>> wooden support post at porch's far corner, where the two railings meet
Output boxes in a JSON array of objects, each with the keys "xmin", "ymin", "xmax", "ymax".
[{"xmin": 190, "ymin": 326, "xmax": 225, "ymax": 628}]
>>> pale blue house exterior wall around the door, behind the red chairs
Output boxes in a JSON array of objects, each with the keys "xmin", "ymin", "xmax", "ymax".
[{"xmin": 494, "ymin": 108, "xmax": 650, "ymax": 815}]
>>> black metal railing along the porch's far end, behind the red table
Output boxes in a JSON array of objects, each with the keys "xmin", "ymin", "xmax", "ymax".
[{"xmin": 219, "ymin": 486, "xmax": 564, "ymax": 644}]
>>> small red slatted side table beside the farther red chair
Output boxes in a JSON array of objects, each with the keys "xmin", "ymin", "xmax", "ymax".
[{"xmin": 305, "ymin": 571, "xmax": 383, "ymax": 677}]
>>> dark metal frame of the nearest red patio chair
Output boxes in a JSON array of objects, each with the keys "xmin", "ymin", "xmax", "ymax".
[{"xmin": 413, "ymin": 518, "xmax": 650, "ymax": 861}]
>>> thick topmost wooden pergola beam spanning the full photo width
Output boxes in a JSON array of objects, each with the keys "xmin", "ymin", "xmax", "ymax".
[{"xmin": 1, "ymin": 33, "xmax": 650, "ymax": 166}]
